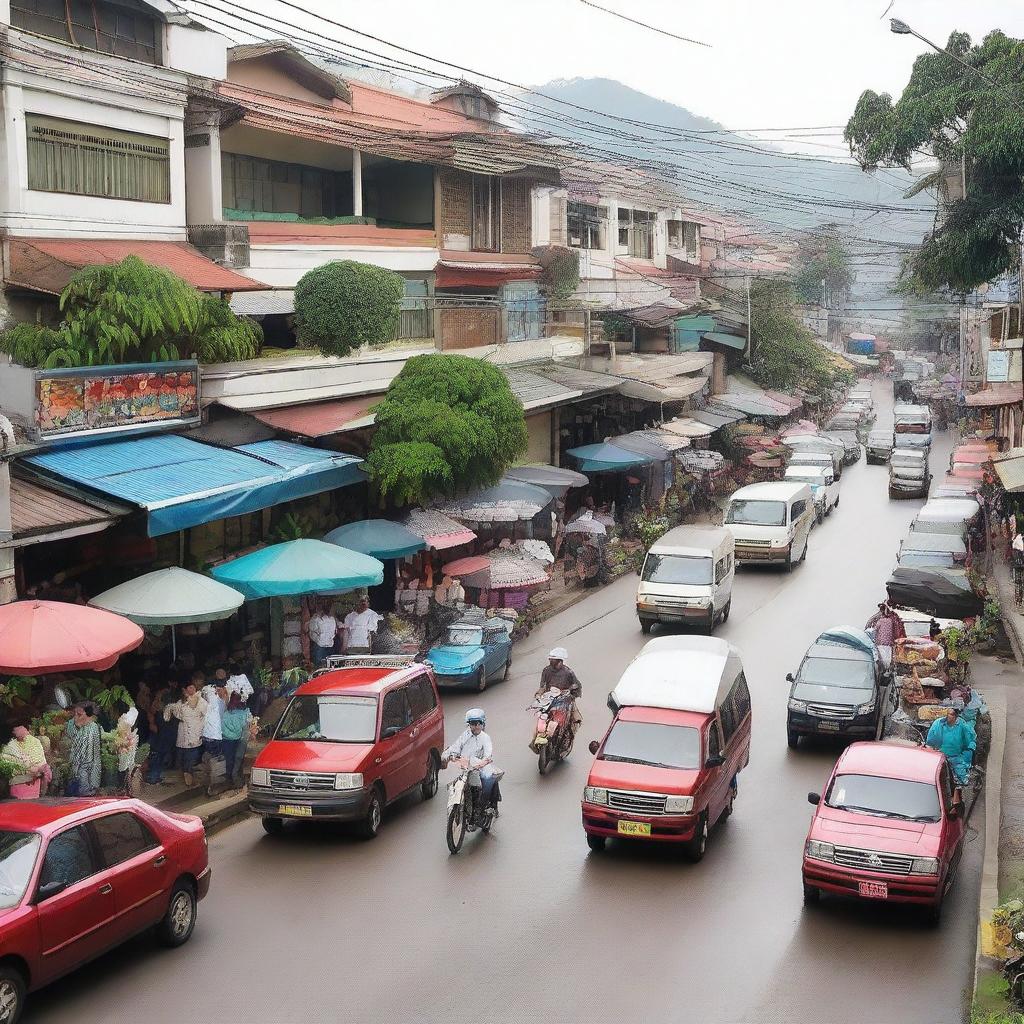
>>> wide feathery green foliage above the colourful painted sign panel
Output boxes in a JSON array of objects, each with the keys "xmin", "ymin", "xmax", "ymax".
[{"xmin": 0, "ymin": 256, "xmax": 263, "ymax": 370}]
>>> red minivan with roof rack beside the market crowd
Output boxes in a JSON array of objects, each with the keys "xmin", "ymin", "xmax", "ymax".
[{"xmin": 249, "ymin": 656, "xmax": 444, "ymax": 839}]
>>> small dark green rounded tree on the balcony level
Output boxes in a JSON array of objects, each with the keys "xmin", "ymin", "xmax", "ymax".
[{"xmin": 295, "ymin": 260, "xmax": 406, "ymax": 355}]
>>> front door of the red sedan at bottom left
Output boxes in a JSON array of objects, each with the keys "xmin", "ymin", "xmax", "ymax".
[{"xmin": 33, "ymin": 824, "xmax": 119, "ymax": 987}]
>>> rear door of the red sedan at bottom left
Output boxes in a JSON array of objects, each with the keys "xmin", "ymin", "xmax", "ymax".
[{"xmin": 92, "ymin": 811, "xmax": 174, "ymax": 939}]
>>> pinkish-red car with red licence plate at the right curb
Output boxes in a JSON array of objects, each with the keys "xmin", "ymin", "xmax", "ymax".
[{"xmin": 803, "ymin": 742, "xmax": 965, "ymax": 924}]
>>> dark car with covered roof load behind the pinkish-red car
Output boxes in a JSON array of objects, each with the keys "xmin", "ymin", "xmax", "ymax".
[{"xmin": 785, "ymin": 626, "xmax": 898, "ymax": 749}]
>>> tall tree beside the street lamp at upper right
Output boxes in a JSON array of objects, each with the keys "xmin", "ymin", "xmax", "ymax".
[{"xmin": 844, "ymin": 32, "xmax": 1024, "ymax": 294}]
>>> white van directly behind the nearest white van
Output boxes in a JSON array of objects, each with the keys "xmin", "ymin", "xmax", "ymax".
[{"xmin": 725, "ymin": 480, "xmax": 814, "ymax": 570}]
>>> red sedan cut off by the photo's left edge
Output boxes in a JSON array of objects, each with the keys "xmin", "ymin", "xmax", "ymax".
[{"xmin": 0, "ymin": 799, "xmax": 210, "ymax": 1024}]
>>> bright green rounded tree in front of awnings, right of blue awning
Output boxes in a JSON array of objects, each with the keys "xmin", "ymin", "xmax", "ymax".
[{"xmin": 368, "ymin": 354, "xmax": 528, "ymax": 505}]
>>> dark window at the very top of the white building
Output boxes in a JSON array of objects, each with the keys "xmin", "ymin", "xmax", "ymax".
[{"xmin": 10, "ymin": 0, "xmax": 161, "ymax": 63}]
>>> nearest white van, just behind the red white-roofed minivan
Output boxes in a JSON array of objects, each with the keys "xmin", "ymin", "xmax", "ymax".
[{"xmin": 637, "ymin": 526, "xmax": 735, "ymax": 633}]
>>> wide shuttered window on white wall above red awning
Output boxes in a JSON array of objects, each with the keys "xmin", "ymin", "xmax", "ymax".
[{"xmin": 25, "ymin": 114, "xmax": 171, "ymax": 203}]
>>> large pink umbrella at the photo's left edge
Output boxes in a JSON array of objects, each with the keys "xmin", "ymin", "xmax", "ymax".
[{"xmin": 0, "ymin": 601, "xmax": 142, "ymax": 676}]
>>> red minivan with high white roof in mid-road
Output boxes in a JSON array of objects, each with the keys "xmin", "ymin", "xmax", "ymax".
[{"xmin": 583, "ymin": 636, "xmax": 752, "ymax": 861}]
